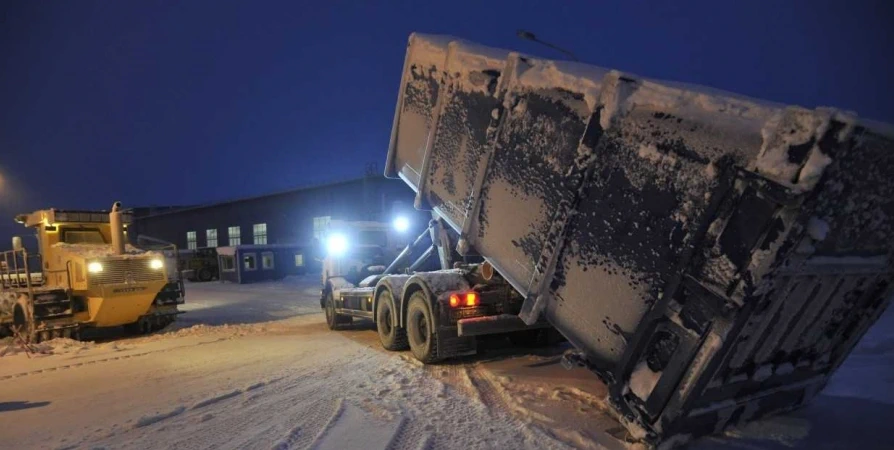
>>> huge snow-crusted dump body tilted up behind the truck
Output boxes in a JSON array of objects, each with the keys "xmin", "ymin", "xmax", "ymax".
[{"xmin": 386, "ymin": 34, "xmax": 894, "ymax": 443}]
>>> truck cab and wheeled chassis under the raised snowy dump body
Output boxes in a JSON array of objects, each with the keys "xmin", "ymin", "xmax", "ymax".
[{"xmin": 320, "ymin": 216, "xmax": 560, "ymax": 354}]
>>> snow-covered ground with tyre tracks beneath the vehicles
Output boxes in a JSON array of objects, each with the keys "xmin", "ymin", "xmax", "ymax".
[{"xmin": 0, "ymin": 277, "xmax": 894, "ymax": 449}]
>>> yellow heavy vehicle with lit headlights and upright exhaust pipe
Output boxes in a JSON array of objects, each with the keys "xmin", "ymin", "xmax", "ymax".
[{"xmin": 0, "ymin": 202, "xmax": 184, "ymax": 342}]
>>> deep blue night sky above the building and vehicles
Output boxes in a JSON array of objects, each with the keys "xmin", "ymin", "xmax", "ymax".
[{"xmin": 0, "ymin": 0, "xmax": 894, "ymax": 243}]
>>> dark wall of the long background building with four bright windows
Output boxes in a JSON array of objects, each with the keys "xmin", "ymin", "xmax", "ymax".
[{"xmin": 128, "ymin": 177, "xmax": 430, "ymax": 248}]
